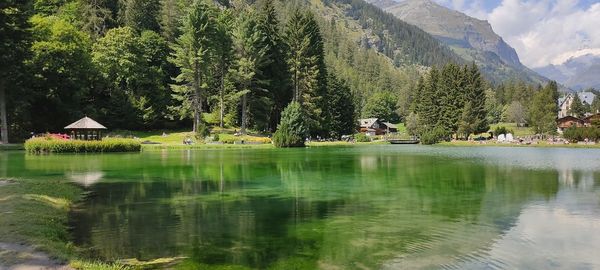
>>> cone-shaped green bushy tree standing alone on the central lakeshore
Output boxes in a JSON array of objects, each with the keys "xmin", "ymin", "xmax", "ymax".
[{"xmin": 273, "ymin": 102, "xmax": 308, "ymax": 147}]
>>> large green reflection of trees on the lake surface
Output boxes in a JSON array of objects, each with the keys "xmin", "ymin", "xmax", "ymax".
[{"xmin": 72, "ymin": 150, "xmax": 558, "ymax": 269}]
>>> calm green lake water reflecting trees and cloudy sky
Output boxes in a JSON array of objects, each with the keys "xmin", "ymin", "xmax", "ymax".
[{"xmin": 0, "ymin": 145, "xmax": 600, "ymax": 269}]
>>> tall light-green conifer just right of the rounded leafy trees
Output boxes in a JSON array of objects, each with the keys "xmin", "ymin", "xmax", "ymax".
[{"xmin": 171, "ymin": 0, "xmax": 216, "ymax": 133}]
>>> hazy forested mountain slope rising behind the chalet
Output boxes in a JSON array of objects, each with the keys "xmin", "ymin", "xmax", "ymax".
[{"xmin": 298, "ymin": 0, "xmax": 462, "ymax": 115}]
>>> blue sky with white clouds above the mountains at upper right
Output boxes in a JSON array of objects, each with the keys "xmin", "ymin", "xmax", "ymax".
[{"xmin": 398, "ymin": 0, "xmax": 600, "ymax": 67}]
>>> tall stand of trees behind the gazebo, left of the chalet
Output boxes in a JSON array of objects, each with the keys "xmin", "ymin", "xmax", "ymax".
[{"xmin": 0, "ymin": 0, "xmax": 355, "ymax": 142}]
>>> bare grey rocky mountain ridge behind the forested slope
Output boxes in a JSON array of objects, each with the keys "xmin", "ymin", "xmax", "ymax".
[{"xmin": 367, "ymin": 0, "xmax": 547, "ymax": 83}]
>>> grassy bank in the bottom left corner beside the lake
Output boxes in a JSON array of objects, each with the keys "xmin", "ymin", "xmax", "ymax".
[{"xmin": 0, "ymin": 180, "xmax": 130, "ymax": 270}]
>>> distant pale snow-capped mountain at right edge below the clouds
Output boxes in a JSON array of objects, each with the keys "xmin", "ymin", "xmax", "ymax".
[{"xmin": 534, "ymin": 49, "xmax": 600, "ymax": 90}]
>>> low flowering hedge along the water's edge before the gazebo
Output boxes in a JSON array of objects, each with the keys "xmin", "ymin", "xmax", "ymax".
[{"xmin": 25, "ymin": 137, "xmax": 142, "ymax": 154}]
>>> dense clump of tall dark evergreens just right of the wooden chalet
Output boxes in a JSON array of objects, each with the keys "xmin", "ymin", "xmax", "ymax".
[{"xmin": 409, "ymin": 64, "xmax": 489, "ymax": 143}]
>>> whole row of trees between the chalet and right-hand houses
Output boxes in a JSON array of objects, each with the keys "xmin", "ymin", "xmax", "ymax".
[{"xmin": 405, "ymin": 64, "xmax": 559, "ymax": 143}]
